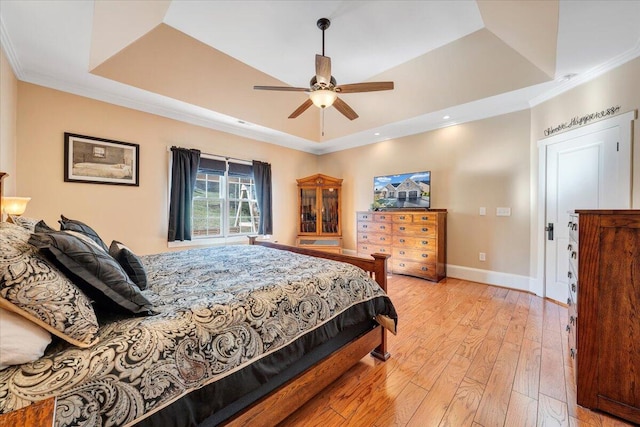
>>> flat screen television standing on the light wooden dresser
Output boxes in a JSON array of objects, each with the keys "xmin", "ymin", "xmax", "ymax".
[{"xmin": 373, "ymin": 171, "xmax": 431, "ymax": 209}]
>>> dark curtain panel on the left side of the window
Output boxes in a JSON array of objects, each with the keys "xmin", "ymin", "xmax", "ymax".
[{"xmin": 168, "ymin": 147, "xmax": 200, "ymax": 242}]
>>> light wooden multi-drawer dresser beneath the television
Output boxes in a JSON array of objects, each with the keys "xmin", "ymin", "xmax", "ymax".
[{"xmin": 357, "ymin": 209, "xmax": 447, "ymax": 282}]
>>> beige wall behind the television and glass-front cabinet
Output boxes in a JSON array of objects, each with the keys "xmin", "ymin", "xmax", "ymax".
[{"xmin": 319, "ymin": 111, "xmax": 530, "ymax": 276}]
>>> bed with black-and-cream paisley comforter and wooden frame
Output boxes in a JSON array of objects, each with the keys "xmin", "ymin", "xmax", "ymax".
[{"xmin": 0, "ymin": 172, "xmax": 397, "ymax": 426}]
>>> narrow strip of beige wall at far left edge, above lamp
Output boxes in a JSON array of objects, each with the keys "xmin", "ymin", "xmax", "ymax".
[{"xmin": 0, "ymin": 47, "xmax": 18, "ymax": 196}]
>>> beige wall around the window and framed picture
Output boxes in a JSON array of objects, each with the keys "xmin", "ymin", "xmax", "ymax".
[{"xmin": 17, "ymin": 82, "xmax": 317, "ymax": 254}]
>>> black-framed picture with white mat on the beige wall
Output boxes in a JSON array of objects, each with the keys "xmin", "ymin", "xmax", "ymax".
[{"xmin": 64, "ymin": 132, "xmax": 140, "ymax": 186}]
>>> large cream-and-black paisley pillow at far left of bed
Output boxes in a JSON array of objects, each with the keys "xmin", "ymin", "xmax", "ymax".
[{"xmin": 0, "ymin": 222, "xmax": 98, "ymax": 347}]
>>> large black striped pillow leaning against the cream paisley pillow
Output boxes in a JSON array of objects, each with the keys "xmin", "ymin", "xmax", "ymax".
[{"xmin": 29, "ymin": 231, "xmax": 153, "ymax": 314}]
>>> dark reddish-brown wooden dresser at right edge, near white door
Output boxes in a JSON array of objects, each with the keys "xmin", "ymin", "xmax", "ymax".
[{"xmin": 567, "ymin": 210, "xmax": 640, "ymax": 424}]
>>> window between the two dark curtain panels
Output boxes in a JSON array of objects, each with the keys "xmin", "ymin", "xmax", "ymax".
[{"xmin": 191, "ymin": 156, "xmax": 260, "ymax": 239}]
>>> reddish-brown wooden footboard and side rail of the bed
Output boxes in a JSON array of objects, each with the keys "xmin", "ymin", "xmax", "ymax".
[{"xmin": 0, "ymin": 172, "xmax": 390, "ymax": 427}]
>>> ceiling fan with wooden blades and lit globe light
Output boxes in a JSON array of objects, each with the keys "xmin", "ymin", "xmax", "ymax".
[{"xmin": 253, "ymin": 18, "xmax": 393, "ymax": 120}]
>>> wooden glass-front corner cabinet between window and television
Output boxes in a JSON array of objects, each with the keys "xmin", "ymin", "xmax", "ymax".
[{"xmin": 296, "ymin": 174, "xmax": 342, "ymax": 253}]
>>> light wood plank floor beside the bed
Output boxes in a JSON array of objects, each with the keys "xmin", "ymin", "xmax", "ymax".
[{"xmin": 281, "ymin": 275, "xmax": 630, "ymax": 427}]
